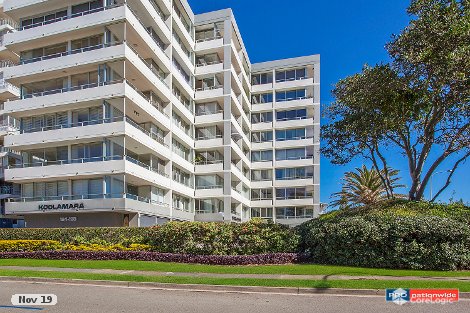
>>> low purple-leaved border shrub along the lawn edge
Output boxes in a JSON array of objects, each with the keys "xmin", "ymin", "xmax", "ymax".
[{"xmin": 0, "ymin": 251, "xmax": 301, "ymax": 265}]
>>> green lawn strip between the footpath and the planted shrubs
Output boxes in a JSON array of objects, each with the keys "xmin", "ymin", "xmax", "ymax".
[{"xmin": 0, "ymin": 259, "xmax": 470, "ymax": 277}]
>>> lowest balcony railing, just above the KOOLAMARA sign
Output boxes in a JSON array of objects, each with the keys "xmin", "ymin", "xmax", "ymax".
[{"xmin": 9, "ymin": 193, "xmax": 169, "ymax": 206}]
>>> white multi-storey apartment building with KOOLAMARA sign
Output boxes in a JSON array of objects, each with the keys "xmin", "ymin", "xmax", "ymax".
[{"xmin": 0, "ymin": 0, "xmax": 320, "ymax": 227}]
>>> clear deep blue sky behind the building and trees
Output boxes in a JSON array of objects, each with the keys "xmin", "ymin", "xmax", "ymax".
[{"xmin": 189, "ymin": 0, "xmax": 470, "ymax": 202}]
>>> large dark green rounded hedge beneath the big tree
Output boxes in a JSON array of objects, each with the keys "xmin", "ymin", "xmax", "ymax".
[{"xmin": 298, "ymin": 215, "xmax": 470, "ymax": 270}]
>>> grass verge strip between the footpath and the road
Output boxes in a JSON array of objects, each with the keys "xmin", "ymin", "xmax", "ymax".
[{"xmin": 0, "ymin": 270, "xmax": 470, "ymax": 292}]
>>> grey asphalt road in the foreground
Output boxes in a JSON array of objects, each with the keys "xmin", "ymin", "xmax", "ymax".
[{"xmin": 0, "ymin": 282, "xmax": 470, "ymax": 313}]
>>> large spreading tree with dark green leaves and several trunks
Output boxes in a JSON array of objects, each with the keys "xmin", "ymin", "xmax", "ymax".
[{"xmin": 322, "ymin": 0, "xmax": 470, "ymax": 201}]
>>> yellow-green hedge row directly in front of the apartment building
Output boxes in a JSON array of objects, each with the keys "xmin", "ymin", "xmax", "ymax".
[{"xmin": 0, "ymin": 220, "xmax": 298, "ymax": 255}]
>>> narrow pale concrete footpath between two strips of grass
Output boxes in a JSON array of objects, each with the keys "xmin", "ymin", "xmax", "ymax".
[{"xmin": 0, "ymin": 266, "xmax": 470, "ymax": 283}]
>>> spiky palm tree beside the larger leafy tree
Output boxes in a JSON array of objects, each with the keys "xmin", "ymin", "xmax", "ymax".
[{"xmin": 330, "ymin": 165, "xmax": 402, "ymax": 209}]
